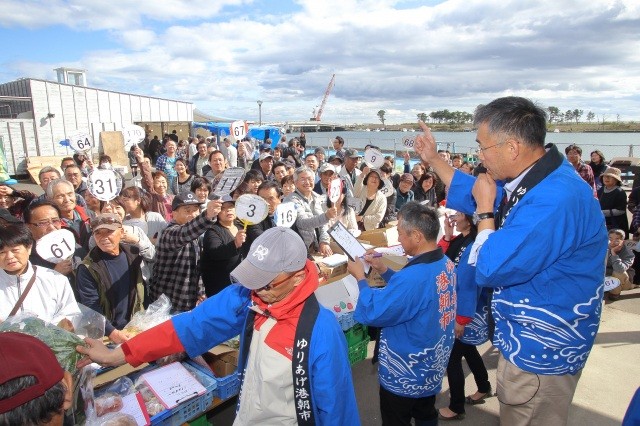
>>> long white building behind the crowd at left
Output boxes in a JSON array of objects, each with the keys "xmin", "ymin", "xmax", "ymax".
[{"xmin": 0, "ymin": 68, "xmax": 193, "ymax": 175}]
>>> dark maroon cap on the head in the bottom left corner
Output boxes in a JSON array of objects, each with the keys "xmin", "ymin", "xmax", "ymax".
[{"xmin": 0, "ymin": 331, "xmax": 64, "ymax": 413}]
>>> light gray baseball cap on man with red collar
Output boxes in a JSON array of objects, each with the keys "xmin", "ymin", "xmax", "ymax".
[{"xmin": 229, "ymin": 226, "xmax": 307, "ymax": 290}]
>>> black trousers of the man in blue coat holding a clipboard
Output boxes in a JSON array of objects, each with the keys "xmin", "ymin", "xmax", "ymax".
[{"xmin": 380, "ymin": 386, "xmax": 438, "ymax": 426}]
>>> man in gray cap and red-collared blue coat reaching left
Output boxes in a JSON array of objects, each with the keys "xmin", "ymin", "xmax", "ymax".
[{"xmin": 77, "ymin": 227, "xmax": 360, "ymax": 425}]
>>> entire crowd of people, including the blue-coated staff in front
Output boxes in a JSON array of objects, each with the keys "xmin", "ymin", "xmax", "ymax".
[{"xmin": 0, "ymin": 97, "xmax": 640, "ymax": 425}]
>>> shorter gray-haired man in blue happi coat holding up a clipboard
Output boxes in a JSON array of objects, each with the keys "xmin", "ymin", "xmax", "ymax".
[{"xmin": 348, "ymin": 201, "xmax": 456, "ymax": 426}]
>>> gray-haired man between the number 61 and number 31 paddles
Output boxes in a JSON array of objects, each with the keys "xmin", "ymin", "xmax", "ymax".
[{"xmin": 46, "ymin": 179, "xmax": 91, "ymax": 247}]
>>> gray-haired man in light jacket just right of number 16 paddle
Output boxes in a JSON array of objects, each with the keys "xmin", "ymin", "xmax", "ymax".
[{"xmin": 284, "ymin": 166, "xmax": 338, "ymax": 256}]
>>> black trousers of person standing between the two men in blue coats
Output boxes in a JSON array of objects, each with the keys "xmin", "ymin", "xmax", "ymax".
[{"xmin": 447, "ymin": 339, "xmax": 491, "ymax": 414}]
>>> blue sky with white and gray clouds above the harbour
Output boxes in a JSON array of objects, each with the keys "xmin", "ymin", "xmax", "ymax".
[{"xmin": 0, "ymin": 0, "xmax": 640, "ymax": 124}]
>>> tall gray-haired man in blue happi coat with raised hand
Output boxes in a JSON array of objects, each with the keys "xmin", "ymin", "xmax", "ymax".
[{"xmin": 414, "ymin": 96, "xmax": 608, "ymax": 425}]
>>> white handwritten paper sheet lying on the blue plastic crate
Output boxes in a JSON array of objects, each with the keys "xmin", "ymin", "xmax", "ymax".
[{"xmin": 141, "ymin": 362, "xmax": 207, "ymax": 409}]
